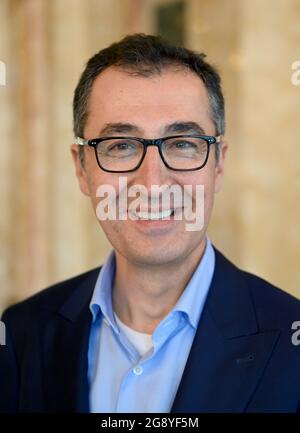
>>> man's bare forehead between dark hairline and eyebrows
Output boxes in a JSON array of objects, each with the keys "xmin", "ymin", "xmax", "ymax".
[{"xmin": 86, "ymin": 67, "xmax": 213, "ymax": 135}]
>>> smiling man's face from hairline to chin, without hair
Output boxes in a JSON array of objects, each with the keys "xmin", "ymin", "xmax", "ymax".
[{"xmin": 71, "ymin": 67, "xmax": 227, "ymax": 266}]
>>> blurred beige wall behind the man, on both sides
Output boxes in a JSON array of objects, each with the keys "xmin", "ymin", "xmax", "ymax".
[{"xmin": 0, "ymin": 0, "xmax": 300, "ymax": 311}]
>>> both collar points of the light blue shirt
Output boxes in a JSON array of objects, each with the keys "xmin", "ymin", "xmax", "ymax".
[{"xmin": 89, "ymin": 237, "xmax": 215, "ymax": 333}]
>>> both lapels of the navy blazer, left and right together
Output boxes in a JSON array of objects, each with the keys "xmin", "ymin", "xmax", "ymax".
[{"xmin": 39, "ymin": 246, "xmax": 279, "ymax": 412}]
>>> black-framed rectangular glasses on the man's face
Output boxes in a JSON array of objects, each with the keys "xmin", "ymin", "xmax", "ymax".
[{"xmin": 76, "ymin": 135, "xmax": 221, "ymax": 173}]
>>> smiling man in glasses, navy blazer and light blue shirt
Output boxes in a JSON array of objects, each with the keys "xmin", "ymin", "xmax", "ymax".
[{"xmin": 0, "ymin": 35, "xmax": 300, "ymax": 412}]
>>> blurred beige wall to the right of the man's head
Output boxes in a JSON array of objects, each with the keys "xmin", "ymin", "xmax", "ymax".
[{"xmin": 189, "ymin": 0, "xmax": 300, "ymax": 297}]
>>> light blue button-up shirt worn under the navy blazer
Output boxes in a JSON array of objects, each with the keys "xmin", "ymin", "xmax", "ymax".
[{"xmin": 88, "ymin": 238, "xmax": 215, "ymax": 413}]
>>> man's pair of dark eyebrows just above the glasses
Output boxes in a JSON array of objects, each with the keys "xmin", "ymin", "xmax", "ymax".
[{"xmin": 99, "ymin": 121, "xmax": 205, "ymax": 136}]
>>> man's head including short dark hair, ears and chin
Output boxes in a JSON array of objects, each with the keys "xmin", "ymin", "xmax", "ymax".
[{"xmin": 72, "ymin": 35, "xmax": 227, "ymax": 265}]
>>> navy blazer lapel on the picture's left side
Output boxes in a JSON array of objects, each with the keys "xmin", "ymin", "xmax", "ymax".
[{"xmin": 40, "ymin": 268, "xmax": 100, "ymax": 412}]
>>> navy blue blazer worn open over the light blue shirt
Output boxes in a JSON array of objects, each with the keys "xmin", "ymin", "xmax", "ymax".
[{"xmin": 0, "ymin": 246, "xmax": 300, "ymax": 413}]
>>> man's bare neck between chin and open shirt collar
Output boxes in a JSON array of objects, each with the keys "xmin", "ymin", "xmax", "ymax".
[{"xmin": 112, "ymin": 239, "xmax": 206, "ymax": 334}]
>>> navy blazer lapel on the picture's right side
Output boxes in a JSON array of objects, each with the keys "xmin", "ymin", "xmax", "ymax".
[{"xmin": 171, "ymin": 250, "xmax": 279, "ymax": 412}]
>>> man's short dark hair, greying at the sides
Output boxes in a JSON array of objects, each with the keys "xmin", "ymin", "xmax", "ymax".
[{"xmin": 73, "ymin": 33, "xmax": 225, "ymax": 163}]
